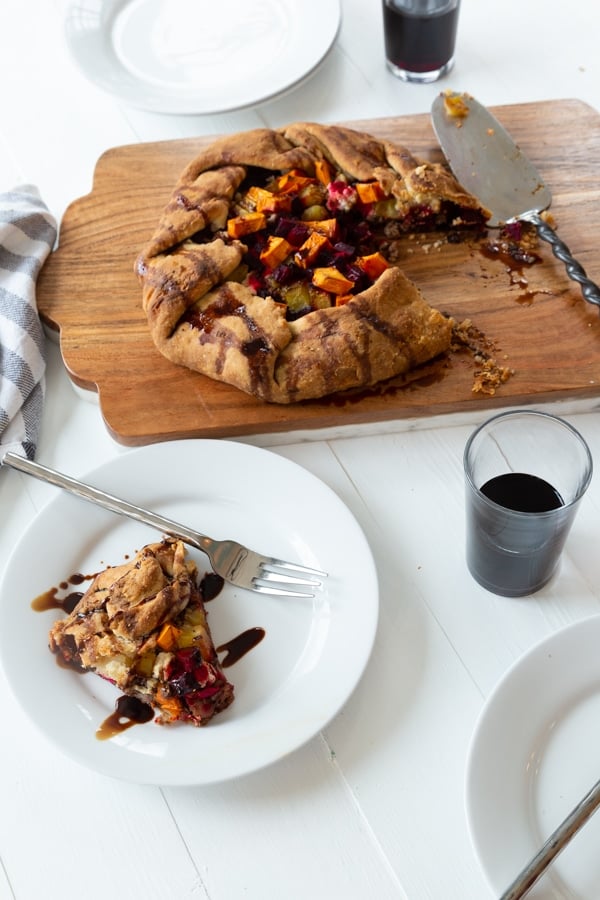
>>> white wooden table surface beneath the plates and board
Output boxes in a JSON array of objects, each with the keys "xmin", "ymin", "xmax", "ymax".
[{"xmin": 0, "ymin": 0, "xmax": 600, "ymax": 900}]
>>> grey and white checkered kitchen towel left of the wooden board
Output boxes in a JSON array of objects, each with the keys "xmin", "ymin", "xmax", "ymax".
[{"xmin": 0, "ymin": 185, "xmax": 56, "ymax": 459}]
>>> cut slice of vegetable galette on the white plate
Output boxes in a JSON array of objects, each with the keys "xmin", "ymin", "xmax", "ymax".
[{"xmin": 50, "ymin": 539, "xmax": 233, "ymax": 725}]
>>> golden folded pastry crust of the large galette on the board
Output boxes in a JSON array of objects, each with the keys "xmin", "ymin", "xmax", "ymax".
[{"xmin": 136, "ymin": 123, "xmax": 489, "ymax": 403}]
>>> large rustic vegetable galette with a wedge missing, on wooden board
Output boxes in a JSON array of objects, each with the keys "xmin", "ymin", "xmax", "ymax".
[{"xmin": 136, "ymin": 123, "xmax": 489, "ymax": 403}]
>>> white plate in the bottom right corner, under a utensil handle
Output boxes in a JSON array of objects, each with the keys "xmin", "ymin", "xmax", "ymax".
[{"xmin": 466, "ymin": 616, "xmax": 600, "ymax": 900}]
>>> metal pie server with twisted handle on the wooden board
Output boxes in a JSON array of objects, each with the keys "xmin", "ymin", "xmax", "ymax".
[{"xmin": 431, "ymin": 92, "xmax": 600, "ymax": 306}]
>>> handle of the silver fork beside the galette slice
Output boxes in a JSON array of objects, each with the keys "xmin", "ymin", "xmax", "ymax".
[{"xmin": 2, "ymin": 450, "xmax": 213, "ymax": 556}]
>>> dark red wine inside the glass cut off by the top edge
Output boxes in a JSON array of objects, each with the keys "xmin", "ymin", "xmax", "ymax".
[{"xmin": 383, "ymin": 2, "xmax": 458, "ymax": 73}]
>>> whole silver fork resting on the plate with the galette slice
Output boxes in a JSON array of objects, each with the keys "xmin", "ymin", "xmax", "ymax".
[{"xmin": 2, "ymin": 450, "xmax": 327, "ymax": 597}]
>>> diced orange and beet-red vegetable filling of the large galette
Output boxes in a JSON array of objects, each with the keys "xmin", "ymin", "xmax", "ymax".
[{"xmin": 194, "ymin": 160, "xmax": 478, "ymax": 320}]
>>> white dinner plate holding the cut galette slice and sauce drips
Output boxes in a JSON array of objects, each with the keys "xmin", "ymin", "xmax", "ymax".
[{"xmin": 0, "ymin": 440, "xmax": 378, "ymax": 785}]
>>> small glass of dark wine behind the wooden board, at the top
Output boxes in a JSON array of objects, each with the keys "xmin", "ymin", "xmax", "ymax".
[{"xmin": 382, "ymin": 0, "xmax": 460, "ymax": 83}]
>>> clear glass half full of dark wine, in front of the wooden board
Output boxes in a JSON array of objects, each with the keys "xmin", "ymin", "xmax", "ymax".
[{"xmin": 464, "ymin": 410, "xmax": 593, "ymax": 597}]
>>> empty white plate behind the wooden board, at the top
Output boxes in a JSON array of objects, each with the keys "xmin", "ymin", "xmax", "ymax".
[{"xmin": 65, "ymin": 0, "xmax": 341, "ymax": 114}]
